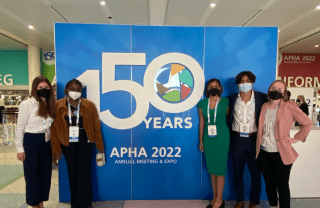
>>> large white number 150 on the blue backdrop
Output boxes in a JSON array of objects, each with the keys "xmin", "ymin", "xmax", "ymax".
[{"xmin": 77, "ymin": 53, "xmax": 204, "ymax": 129}]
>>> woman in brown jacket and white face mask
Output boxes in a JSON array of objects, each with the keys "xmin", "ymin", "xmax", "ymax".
[{"xmin": 51, "ymin": 79, "xmax": 104, "ymax": 208}]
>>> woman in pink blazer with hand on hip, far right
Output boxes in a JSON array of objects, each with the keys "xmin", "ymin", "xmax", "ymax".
[{"xmin": 256, "ymin": 80, "xmax": 312, "ymax": 208}]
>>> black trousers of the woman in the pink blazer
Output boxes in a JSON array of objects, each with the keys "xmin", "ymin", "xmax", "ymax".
[{"xmin": 258, "ymin": 150, "xmax": 292, "ymax": 208}]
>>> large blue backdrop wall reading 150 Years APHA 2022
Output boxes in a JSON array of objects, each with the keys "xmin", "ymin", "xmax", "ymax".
[{"xmin": 55, "ymin": 23, "xmax": 278, "ymax": 201}]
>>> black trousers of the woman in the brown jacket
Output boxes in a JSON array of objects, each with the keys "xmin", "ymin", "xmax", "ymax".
[{"xmin": 61, "ymin": 129, "xmax": 93, "ymax": 208}]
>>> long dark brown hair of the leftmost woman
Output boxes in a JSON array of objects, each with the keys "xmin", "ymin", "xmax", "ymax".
[{"xmin": 31, "ymin": 75, "xmax": 55, "ymax": 118}]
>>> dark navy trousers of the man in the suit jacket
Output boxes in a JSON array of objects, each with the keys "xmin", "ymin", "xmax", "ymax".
[{"xmin": 230, "ymin": 132, "xmax": 261, "ymax": 205}]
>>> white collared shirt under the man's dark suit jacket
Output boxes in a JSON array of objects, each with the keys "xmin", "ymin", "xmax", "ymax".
[{"xmin": 232, "ymin": 90, "xmax": 257, "ymax": 133}]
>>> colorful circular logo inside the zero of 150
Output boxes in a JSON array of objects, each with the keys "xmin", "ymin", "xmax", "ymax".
[{"xmin": 154, "ymin": 63, "xmax": 194, "ymax": 103}]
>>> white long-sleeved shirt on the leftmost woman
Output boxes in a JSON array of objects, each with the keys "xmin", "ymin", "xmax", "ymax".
[{"xmin": 15, "ymin": 97, "xmax": 52, "ymax": 153}]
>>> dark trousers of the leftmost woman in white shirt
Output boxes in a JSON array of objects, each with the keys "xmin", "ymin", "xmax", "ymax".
[{"xmin": 23, "ymin": 133, "xmax": 52, "ymax": 206}]
